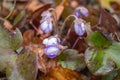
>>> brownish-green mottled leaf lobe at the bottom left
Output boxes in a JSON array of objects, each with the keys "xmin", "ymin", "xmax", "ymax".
[{"xmin": 16, "ymin": 50, "xmax": 38, "ymax": 80}]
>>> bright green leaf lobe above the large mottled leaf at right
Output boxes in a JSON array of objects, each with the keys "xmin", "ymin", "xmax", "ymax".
[{"xmin": 87, "ymin": 32, "xmax": 111, "ymax": 48}]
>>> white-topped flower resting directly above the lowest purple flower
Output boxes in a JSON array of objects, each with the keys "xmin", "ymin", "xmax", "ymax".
[{"xmin": 43, "ymin": 36, "xmax": 60, "ymax": 46}]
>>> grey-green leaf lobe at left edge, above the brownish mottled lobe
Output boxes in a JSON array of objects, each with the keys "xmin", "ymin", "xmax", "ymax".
[{"xmin": 0, "ymin": 26, "xmax": 23, "ymax": 50}]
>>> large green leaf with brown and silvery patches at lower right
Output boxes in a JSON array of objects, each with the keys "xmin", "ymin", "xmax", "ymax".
[{"xmin": 85, "ymin": 42, "xmax": 120, "ymax": 75}]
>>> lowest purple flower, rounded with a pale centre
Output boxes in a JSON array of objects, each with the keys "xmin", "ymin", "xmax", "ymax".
[{"xmin": 44, "ymin": 45, "xmax": 60, "ymax": 58}]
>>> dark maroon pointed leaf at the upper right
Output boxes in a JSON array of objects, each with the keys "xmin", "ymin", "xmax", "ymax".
[{"xmin": 99, "ymin": 9, "xmax": 118, "ymax": 33}]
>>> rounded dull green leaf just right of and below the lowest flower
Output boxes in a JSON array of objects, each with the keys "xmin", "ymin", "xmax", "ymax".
[{"xmin": 58, "ymin": 49, "xmax": 85, "ymax": 70}]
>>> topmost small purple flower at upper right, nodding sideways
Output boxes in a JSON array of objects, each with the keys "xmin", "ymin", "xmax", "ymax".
[{"xmin": 74, "ymin": 6, "xmax": 89, "ymax": 18}]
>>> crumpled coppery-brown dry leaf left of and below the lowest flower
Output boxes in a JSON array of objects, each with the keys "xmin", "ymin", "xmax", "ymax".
[{"xmin": 29, "ymin": 44, "xmax": 59, "ymax": 73}]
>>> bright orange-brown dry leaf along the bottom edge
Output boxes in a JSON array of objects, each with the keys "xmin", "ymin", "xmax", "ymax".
[{"xmin": 39, "ymin": 67, "xmax": 87, "ymax": 80}]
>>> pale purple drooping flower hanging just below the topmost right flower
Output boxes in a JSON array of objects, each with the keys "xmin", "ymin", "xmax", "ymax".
[{"xmin": 74, "ymin": 19, "xmax": 86, "ymax": 36}]
